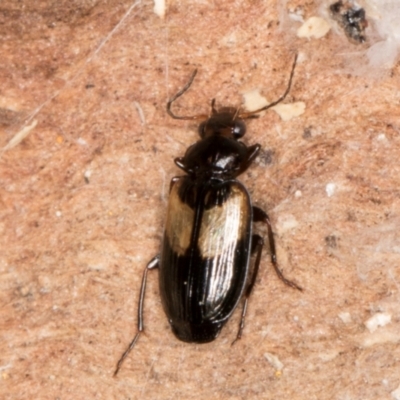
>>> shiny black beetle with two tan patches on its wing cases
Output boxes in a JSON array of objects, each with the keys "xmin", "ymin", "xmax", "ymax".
[{"xmin": 114, "ymin": 56, "xmax": 302, "ymax": 376}]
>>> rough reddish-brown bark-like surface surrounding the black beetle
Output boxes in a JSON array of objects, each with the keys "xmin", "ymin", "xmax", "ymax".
[{"xmin": 0, "ymin": 0, "xmax": 400, "ymax": 400}]
